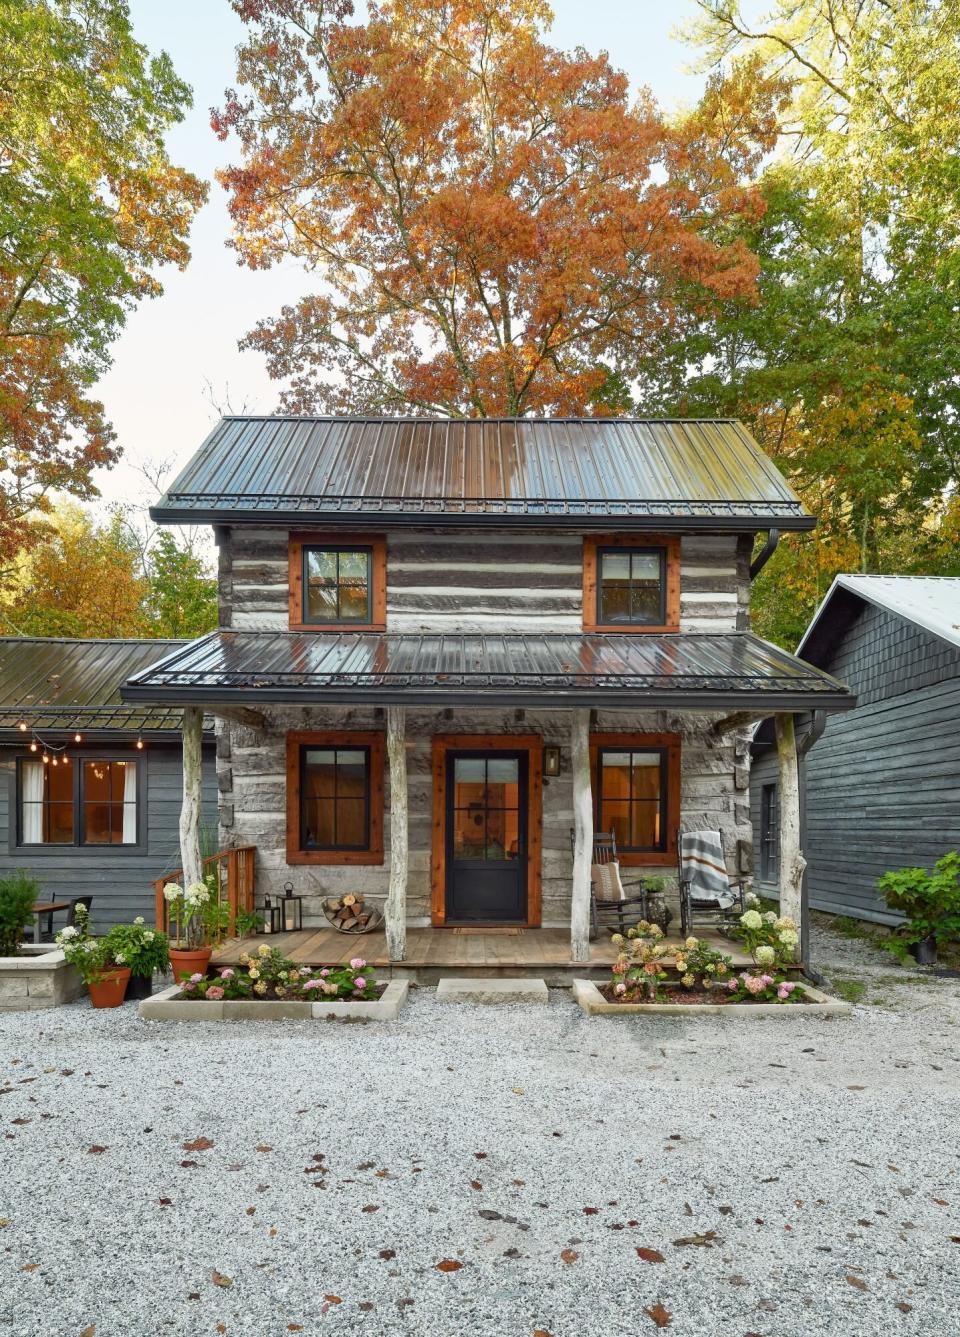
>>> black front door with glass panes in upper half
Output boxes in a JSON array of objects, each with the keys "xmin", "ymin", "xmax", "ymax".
[{"xmin": 447, "ymin": 749, "xmax": 527, "ymax": 924}]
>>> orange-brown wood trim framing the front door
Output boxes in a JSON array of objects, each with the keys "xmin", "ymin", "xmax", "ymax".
[{"xmin": 431, "ymin": 734, "xmax": 543, "ymax": 928}]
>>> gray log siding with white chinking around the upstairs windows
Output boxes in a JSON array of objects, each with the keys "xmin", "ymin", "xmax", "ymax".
[{"xmin": 218, "ymin": 525, "xmax": 751, "ymax": 632}]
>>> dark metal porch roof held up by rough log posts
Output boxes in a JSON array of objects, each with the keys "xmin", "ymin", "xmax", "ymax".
[{"xmin": 122, "ymin": 631, "xmax": 856, "ymax": 711}]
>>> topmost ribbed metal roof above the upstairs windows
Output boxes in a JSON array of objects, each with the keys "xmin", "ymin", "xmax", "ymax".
[{"xmin": 151, "ymin": 416, "xmax": 814, "ymax": 531}]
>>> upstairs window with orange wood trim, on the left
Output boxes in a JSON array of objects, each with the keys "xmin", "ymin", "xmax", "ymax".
[{"xmin": 290, "ymin": 533, "xmax": 386, "ymax": 631}]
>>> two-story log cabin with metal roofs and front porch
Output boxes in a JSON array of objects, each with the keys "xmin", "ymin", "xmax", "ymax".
[{"xmin": 123, "ymin": 416, "xmax": 853, "ymax": 964}]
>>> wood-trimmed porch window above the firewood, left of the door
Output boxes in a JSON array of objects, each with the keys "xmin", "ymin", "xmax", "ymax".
[{"xmin": 286, "ymin": 731, "xmax": 384, "ymax": 864}]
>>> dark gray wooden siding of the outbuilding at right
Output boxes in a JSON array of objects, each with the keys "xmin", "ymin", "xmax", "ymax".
[{"xmin": 750, "ymin": 603, "xmax": 960, "ymax": 924}]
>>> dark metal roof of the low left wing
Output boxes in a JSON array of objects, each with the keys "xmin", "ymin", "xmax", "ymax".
[{"xmin": 0, "ymin": 636, "xmax": 207, "ymax": 735}]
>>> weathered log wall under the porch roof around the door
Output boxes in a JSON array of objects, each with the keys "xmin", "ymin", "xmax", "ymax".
[{"xmin": 218, "ymin": 707, "xmax": 750, "ymax": 927}]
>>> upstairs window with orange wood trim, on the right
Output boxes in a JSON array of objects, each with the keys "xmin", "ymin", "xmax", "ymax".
[{"xmin": 583, "ymin": 533, "xmax": 681, "ymax": 632}]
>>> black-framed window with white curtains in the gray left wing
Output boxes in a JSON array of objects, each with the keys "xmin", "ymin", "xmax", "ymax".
[{"xmin": 17, "ymin": 757, "xmax": 139, "ymax": 845}]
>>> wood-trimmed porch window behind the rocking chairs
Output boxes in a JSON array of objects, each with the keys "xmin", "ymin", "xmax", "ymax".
[{"xmin": 590, "ymin": 734, "xmax": 681, "ymax": 864}]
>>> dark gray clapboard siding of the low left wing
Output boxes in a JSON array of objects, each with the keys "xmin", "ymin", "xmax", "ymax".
[{"xmin": 0, "ymin": 742, "xmax": 217, "ymax": 932}]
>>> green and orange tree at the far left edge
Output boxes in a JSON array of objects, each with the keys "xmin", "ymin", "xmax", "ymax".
[{"xmin": 0, "ymin": 0, "xmax": 206, "ymax": 566}]
